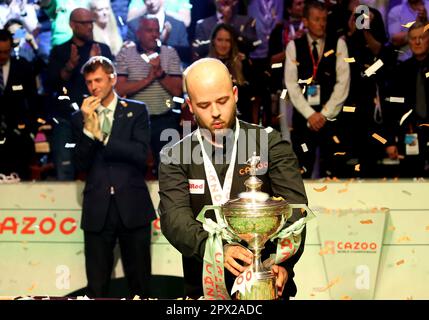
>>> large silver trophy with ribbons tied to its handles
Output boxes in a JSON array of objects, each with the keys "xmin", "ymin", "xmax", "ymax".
[{"xmin": 198, "ymin": 154, "xmax": 314, "ymax": 300}]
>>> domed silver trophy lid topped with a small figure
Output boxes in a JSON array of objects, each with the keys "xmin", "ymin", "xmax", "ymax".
[{"xmin": 222, "ymin": 152, "xmax": 289, "ymax": 213}]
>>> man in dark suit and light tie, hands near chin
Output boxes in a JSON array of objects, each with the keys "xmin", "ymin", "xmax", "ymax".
[{"xmin": 72, "ymin": 56, "xmax": 155, "ymax": 297}]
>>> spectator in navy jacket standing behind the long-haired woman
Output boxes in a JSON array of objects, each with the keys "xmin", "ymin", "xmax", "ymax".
[{"xmin": 192, "ymin": 0, "xmax": 257, "ymax": 59}]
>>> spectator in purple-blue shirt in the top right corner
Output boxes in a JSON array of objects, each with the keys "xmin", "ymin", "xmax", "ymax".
[{"xmin": 387, "ymin": 0, "xmax": 429, "ymax": 61}]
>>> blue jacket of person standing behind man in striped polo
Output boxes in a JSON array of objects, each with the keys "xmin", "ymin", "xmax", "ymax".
[{"xmin": 127, "ymin": 14, "xmax": 191, "ymax": 62}]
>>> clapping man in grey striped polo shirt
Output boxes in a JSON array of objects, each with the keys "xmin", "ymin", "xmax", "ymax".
[{"xmin": 116, "ymin": 15, "xmax": 182, "ymax": 177}]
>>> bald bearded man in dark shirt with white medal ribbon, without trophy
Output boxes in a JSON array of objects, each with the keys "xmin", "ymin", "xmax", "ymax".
[{"xmin": 159, "ymin": 58, "xmax": 307, "ymax": 299}]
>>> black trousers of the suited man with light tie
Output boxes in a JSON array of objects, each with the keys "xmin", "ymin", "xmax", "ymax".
[{"xmin": 84, "ymin": 196, "xmax": 151, "ymax": 298}]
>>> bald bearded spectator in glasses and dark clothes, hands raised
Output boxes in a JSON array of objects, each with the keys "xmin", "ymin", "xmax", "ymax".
[{"xmin": 48, "ymin": 8, "xmax": 113, "ymax": 181}]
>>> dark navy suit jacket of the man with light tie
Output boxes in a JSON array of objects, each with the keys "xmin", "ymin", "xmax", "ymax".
[{"xmin": 72, "ymin": 98, "xmax": 156, "ymax": 232}]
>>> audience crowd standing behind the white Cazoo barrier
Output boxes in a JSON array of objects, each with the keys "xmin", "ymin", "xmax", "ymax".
[{"xmin": 0, "ymin": 0, "xmax": 429, "ymax": 182}]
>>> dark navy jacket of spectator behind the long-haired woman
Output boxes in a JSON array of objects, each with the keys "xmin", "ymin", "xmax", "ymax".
[{"xmin": 193, "ymin": 15, "xmax": 258, "ymax": 58}]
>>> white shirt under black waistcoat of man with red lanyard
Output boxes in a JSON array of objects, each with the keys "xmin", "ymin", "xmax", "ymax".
[{"xmin": 285, "ymin": 33, "xmax": 350, "ymax": 119}]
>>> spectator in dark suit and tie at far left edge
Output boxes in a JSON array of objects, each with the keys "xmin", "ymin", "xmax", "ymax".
[{"xmin": 0, "ymin": 29, "xmax": 38, "ymax": 180}]
